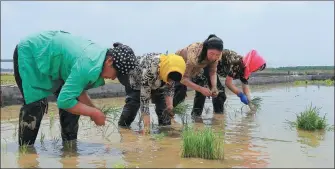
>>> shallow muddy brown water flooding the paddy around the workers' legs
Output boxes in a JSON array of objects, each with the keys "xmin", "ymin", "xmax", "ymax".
[{"xmin": 1, "ymin": 85, "xmax": 334, "ymax": 168}]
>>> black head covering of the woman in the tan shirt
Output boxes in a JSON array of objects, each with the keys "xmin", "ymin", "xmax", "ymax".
[{"xmin": 198, "ymin": 34, "xmax": 223, "ymax": 63}]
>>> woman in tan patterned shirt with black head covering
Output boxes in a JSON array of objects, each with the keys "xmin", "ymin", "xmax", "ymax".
[{"xmin": 168, "ymin": 34, "xmax": 223, "ymax": 116}]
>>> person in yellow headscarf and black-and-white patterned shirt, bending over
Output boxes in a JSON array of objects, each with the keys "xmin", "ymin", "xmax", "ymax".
[{"xmin": 118, "ymin": 50, "xmax": 186, "ymax": 133}]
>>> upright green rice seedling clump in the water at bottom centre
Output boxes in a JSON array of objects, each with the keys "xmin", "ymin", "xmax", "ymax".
[{"xmin": 182, "ymin": 127, "xmax": 224, "ymax": 160}]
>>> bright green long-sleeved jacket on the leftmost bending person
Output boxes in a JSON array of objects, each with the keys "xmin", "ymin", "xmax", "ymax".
[{"xmin": 18, "ymin": 31, "xmax": 108, "ymax": 109}]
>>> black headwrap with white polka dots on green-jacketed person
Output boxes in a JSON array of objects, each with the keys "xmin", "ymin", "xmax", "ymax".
[{"xmin": 107, "ymin": 44, "xmax": 137, "ymax": 75}]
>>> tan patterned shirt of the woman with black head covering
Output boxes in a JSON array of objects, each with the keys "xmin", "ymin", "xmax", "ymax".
[{"xmin": 176, "ymin": 42, "xmax": 221, "ymax": 79}]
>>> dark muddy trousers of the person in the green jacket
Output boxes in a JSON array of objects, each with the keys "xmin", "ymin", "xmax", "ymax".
[{"xmin": 13, "ymin": 46, "xmax": 80, "ymax": 146}]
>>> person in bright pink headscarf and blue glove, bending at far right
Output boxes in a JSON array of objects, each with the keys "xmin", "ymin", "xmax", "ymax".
[{"xmin": 192, "ymin": 49, "xmax": 266, "ymax": 116}]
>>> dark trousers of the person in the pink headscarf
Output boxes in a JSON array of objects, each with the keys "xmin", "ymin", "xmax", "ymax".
[{"xmin": 192, "ymin": 67, "xmax": 227, "ymax": 116}]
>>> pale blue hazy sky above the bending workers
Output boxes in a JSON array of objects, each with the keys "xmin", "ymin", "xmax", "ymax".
[{"xmin": 1, "ymin": 1, "xmax": 334, "ymax": 68}]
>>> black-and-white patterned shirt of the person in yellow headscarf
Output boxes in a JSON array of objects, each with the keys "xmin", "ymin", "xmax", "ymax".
[{"xmin": 129, "ymin": 53, "xmax": 174, "ymax": 114}]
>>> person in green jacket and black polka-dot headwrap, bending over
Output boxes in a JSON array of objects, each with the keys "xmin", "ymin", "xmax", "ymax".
[{"xmin": 13, "ymin": 31, "xmax": 136, "ymax": 146}]
